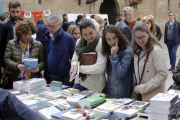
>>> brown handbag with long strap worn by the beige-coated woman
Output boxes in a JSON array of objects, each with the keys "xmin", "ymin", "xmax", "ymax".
[{"xmin": 131, "ymin": 55, "xmax": 149, "ymax": 101}]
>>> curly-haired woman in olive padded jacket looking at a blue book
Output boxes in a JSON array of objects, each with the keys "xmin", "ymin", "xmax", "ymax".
[{"xmin": 4, "ymin": 20, "xmax": 45, "ymax": 89}]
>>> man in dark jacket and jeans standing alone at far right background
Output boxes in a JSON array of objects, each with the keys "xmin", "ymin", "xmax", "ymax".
[{"xmin": 164, "ymin": 12, "xmax": 180, "ymax": 72}]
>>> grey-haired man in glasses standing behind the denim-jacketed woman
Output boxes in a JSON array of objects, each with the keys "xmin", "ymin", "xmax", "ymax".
[{"xmin": 117, "ymin": 7, "xmax": 133, "ymax": 43}]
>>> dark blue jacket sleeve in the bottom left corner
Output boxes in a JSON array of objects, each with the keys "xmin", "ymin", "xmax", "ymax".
[{"xmin": 0, "ymin": 88, "xmax": 44, "ymax": 120}]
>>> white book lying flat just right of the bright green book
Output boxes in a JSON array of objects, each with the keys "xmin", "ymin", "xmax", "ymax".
[{"xmin": 97, "ymin": 101, "xmax": 123, "ymax": 112}]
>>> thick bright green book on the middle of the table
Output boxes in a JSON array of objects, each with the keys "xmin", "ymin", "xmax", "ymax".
[{"xmin": 81, "ymin": 96, "xmax": 104, "ymax": 107}]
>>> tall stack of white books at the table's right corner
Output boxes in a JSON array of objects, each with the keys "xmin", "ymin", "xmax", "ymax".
[{"xmin": 149, "ymin": 93, "xmax": 179, "ymax": 120}]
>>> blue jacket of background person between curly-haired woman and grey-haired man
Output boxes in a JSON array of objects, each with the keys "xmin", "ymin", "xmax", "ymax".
[{"xmin": 36, "ymin": 22, "xmax": 48, "ymax": 46}]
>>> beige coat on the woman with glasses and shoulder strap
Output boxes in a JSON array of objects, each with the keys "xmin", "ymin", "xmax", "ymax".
[{"xmin": 134, "ymin": 45, "xmax": 168, "ymax": 102}]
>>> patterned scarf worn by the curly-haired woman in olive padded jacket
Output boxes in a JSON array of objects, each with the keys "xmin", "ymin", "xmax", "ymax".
[{"xmin": 19, "ymin": 38, "xmax": 33, "ymax": 79}]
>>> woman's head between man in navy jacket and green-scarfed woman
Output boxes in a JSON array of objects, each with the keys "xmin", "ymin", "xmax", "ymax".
[{"xmin": 67, "ymin": 25, "xmax": 81, "ymax": 40}]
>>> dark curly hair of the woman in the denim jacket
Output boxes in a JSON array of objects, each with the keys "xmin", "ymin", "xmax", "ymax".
[{"xmin": 102, "ymin": 25, "xmax": 129, "ymax": 56}]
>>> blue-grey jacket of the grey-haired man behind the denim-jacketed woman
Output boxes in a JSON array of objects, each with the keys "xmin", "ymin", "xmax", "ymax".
[{"xmin": 117, "ymin": 20, "xmax": 132, "ymax": 43}]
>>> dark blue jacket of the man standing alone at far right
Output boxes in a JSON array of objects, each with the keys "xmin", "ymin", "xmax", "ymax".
[{"xmin": 164, "ymin": 20, "xmax": 180, "ymax": 44}]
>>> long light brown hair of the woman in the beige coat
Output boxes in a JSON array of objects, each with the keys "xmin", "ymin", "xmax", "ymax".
[{"xmin": 132, "ymin": 21, "xmax": 162, "ymax": 55}]
